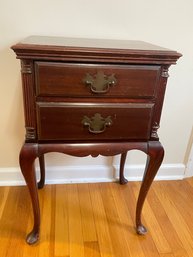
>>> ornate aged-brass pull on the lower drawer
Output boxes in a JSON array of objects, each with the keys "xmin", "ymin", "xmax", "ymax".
[{"xmin": 82, "ymin": 113, "xmax": 113, "ymax": 134}]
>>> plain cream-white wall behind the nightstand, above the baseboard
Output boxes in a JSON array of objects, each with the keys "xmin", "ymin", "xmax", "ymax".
[{"xmin": 0, "ymin": 0, "xmax": 193, "ymax": 184}]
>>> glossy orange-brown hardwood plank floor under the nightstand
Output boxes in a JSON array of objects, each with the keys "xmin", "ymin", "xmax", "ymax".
[{"xmin": 0, "ymin": 178, "xmax": 193, "ymax": 257}]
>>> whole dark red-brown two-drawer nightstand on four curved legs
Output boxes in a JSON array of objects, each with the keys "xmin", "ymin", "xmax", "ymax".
[{"xmin": 12, "ymin": 36, "xmax": 181, "ymax": 244}]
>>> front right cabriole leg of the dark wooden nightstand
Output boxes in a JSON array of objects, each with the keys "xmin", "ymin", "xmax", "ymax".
[{"xmin": 136, "ymin": 141, "xmax": 164, "ymax": 235}]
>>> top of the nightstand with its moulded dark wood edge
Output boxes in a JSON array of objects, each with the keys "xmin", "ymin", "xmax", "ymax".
[{"xmin": 11, "ymin": 36, "xmax": 181, "ymax": 64}]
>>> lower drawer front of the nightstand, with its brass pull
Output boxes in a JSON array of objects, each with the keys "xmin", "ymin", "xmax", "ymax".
[{"xmin": 37, "ymin": 102, "xmax": 154, "ymax": 140}]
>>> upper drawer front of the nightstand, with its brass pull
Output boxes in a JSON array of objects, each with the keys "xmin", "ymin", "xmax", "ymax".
[{"xmin": 35, "ymin": 62, "xmax": 160, "ymax": 98}]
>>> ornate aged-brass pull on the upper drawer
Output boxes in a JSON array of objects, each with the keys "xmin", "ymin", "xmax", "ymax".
[{"xmin": 83, "ymin": 71, "xmax": 117, "ymax": 94}]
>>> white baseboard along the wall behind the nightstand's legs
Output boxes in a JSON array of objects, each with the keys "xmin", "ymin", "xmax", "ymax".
[{"xmin": 0, "ymin": 163, "xmax": 185, "ymax": 186}]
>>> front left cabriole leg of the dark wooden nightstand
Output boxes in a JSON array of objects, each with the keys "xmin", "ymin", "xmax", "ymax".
[{"xmin": 19, "ymin": 143, "xmax": 40, "ymax": 244}]
